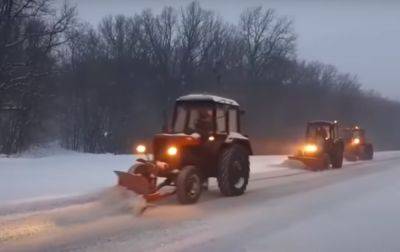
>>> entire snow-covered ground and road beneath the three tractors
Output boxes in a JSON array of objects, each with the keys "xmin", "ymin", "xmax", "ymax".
[{"xmin": 0, "ymin": 151, "xmax": 400, "ymax": 251}]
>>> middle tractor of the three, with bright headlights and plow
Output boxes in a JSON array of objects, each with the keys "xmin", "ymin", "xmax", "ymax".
[{"xmin": 289, "ymin": 121, "xmax": 344, "ymax": 170}]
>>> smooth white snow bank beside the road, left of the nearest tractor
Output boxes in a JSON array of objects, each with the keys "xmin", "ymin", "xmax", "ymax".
[{"xmin": 0, "ymin": 152, "xmax": 136, "ymax": 206}]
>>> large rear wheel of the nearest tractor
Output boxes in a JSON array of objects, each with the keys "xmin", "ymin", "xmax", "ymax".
[{"xmin": 217, "ymin": 145, "xmax": 250, "ymax": 196}]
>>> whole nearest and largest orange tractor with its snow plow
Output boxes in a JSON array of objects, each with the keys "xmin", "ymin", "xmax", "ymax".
[{"xmin": 116, "ymin": 94, "xmax": 252, "ymax": 204}]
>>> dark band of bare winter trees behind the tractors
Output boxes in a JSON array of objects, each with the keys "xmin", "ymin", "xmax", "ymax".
[{"xmin": 0, "ymin": 0, "xmax": 400, "ymax": 153}]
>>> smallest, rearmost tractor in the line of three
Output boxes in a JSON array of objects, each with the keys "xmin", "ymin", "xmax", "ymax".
[{"xmin": 343, "ymin": 126, "xmax": 374, "ymax": 161}]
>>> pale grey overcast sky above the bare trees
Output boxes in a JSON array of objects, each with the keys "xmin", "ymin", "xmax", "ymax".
[{"xmin": 67, "ymin": 0, "xmax": 400, "ymax": 100}]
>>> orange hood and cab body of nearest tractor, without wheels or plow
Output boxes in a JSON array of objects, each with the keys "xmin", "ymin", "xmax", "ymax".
[{"xmin": 153, "ymin": 95, "xmax": 251, "ymax": 177}]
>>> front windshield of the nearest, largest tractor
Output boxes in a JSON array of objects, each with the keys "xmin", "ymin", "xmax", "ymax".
[{"xmin": 173, "ymin": 103, "xmax": 214, "ymax": 135}]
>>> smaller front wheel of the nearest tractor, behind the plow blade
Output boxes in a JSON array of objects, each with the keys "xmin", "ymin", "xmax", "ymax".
[{"xmin": 176, "ymin": 165, "xmax": 202, "ymax": 204}]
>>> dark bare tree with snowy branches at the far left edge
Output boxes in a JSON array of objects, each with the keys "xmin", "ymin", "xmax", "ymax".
[{"xmin": 0, "ymin": 0, "xmax": 75, "ymax": 153}]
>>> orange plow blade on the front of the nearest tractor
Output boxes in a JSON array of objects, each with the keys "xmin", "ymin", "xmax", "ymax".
[{"xmin": 114, "ymin": 171, "xmax": 154, "ymax": 195}]
